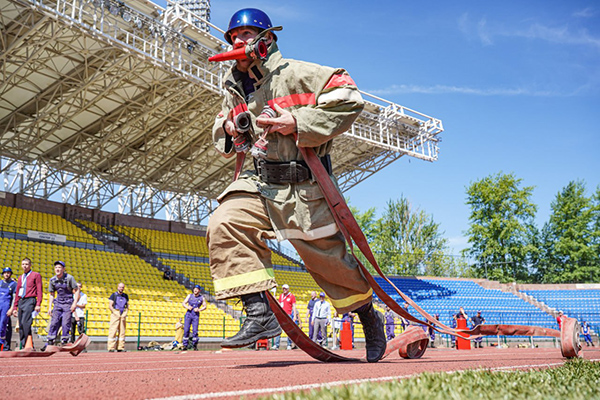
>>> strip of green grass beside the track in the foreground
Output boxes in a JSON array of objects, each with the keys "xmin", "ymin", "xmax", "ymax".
[{"xmin": 262, "ymin": 359, "xmax": 600, "ymax": 400}]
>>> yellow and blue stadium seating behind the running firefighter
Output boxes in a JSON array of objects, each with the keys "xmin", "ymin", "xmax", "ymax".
[{"xmin": 0, "ymin": 198, "xmax": 600, "ymax": 348}]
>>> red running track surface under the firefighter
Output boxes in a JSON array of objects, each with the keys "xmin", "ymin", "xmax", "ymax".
[{"xmin": 0, "ymin": 348, "xmax": 600, "ymax": 400}]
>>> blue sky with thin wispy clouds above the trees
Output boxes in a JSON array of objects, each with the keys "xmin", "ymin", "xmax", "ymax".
[{"xmin": 165, "ymin": 0, "xmax": 600, "ymax": 254}]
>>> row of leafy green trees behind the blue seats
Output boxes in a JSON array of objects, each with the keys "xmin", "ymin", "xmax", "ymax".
[{"xmin": 352, "ymin": 172, "xmax": 600, "ymax": 283}]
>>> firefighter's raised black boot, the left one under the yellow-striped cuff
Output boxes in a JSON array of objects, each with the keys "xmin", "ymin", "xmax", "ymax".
[{"xmin": 221, "ymin": 293, "xmax": 281, "ymax": 348}]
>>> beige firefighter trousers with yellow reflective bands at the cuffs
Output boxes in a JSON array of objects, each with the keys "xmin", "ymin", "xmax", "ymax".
[{"xmin": 207, "ymin": 192, "xmax": 372, "ymax": 313}]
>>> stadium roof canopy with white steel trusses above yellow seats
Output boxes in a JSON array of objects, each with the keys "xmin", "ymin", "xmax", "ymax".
[{"xmin": 0, "ymin": 0, "xmax": 443, "ymax": 223}]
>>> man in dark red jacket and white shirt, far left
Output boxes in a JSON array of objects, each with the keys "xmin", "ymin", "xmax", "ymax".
[{"xmin": 13, "ymin": 258, "xmax": 44, "ymax": 348}]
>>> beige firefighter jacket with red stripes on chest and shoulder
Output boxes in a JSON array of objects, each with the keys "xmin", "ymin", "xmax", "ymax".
[{"xmin": 213, "ymin": 42, "xmax": 364, "ymax": 241}]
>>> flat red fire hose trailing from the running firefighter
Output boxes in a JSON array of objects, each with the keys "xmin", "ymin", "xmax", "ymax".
[{"xmin": 218, "ymin": 94, "xmax": 581, "ymax": 362}]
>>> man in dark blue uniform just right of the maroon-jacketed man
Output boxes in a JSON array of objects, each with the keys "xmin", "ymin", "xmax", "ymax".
[{"xmin": 48, "ymin": 261, "xmax": 79, "ymax": 345}]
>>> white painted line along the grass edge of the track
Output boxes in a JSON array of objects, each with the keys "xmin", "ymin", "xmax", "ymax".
[{"xmin": 146, "ymin": 359, "xmax": 598, "ymax": 400}]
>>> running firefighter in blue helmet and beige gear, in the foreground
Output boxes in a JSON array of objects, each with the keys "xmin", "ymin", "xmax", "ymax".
[{"xmin": 207, "ymin": 8, "xmax": 386, "ymax": 362}]
